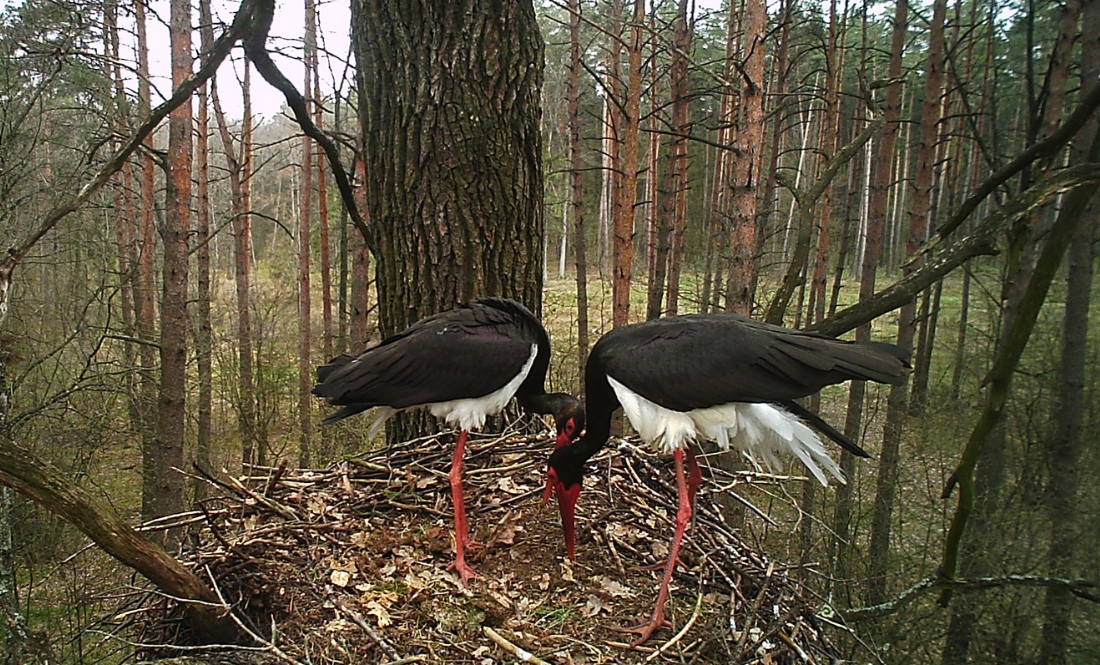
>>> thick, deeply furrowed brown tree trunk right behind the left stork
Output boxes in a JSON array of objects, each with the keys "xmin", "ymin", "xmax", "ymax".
[{"xmin": 354, "ymin": 0, "xmax": 543, "ymax": 435}]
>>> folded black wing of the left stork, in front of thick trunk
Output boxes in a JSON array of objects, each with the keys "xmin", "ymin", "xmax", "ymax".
[{"xmin": 314, "ymin": 303, "xmax": 535, "ymax": 415}]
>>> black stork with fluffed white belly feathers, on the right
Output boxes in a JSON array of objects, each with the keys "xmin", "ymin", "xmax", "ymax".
[{"xmin": 546, "ymin": 313, "xmax": 909, "ymax": 644}]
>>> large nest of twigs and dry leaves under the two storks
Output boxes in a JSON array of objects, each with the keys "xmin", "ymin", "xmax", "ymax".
[{"xmin": 124, "ymin": 433, "xmax": 843, "ymax": 665}]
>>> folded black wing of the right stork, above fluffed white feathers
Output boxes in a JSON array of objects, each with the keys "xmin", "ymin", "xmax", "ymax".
[{"xmin": 593, "ymin": 314, "xmax": 908, "ymax": 411}]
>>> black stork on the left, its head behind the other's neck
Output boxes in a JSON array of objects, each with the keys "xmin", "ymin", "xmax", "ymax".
[{"xmin": 314, "ymin": 298, "xmax": 583, "ymax": 586}]
